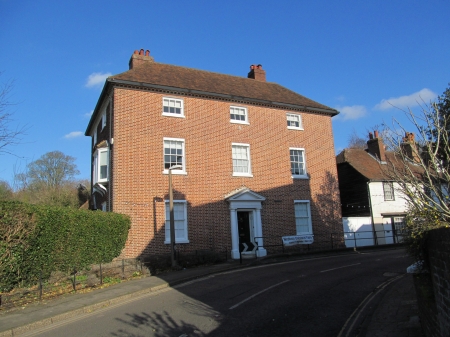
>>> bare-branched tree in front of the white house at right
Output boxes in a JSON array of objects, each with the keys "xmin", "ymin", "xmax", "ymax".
[{"xmin": 385, "ymin": 103, "xmax": 450, "ymax": 221}]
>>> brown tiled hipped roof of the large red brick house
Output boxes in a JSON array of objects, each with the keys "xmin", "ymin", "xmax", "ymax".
[{"xmin": 108, "ymin": 62, "xmax": 338, "ymax": 115}]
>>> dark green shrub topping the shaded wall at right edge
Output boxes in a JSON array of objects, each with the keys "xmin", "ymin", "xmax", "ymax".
[{"xmin": 405, "ymin": 206, "xmax": 450, "ymax": 269}]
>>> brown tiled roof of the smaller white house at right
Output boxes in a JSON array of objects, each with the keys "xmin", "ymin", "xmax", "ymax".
[{"xmin": 336, "ymin": 149, "xmax": 422, "ymax": 181}]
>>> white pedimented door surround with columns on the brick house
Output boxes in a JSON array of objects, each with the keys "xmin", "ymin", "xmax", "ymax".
[{"xmin": 225, "ymin": 187, "xmax": 267, "ymax": 259}]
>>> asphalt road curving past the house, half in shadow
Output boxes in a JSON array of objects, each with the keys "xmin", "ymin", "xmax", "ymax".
[{"xmin": 21, "ymin": 250, "xmax": 411, "ymax": 337}]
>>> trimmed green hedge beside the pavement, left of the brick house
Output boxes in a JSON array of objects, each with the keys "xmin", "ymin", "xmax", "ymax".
[{"xmin": 0, "ymin": 202, "xmax": 130, "ymax": 292}]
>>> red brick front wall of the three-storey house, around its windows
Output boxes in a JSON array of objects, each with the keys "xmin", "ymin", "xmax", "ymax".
[{"xmin": 111, "ymin": 87, "xmax": 342, "ymax": 257}]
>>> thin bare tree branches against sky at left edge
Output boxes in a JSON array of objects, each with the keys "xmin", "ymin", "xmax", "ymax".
[{"xmin": 0, "ymin": 73, "xmax": 25, "ymax": 154}]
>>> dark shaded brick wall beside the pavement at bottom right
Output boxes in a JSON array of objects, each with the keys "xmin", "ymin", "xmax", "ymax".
[{"xmin": 415, "ymin": 228, "xmax": 450, "ymax": 337}]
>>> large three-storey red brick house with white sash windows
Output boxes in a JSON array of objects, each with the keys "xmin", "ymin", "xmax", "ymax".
[{"xmin": 85, "ymin": 50, "xmax": 342, "ymax": 258}]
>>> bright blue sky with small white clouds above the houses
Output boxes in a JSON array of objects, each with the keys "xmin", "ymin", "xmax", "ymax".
[{"xmin": 0, "ymin": 0, "xmax": 450, "ymax": 182}]
